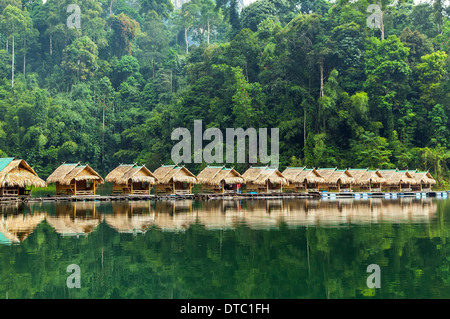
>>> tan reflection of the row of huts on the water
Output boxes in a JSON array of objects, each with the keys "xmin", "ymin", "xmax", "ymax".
[{"xmin": 0, "ymin": 198, "xmax": 438, "ymax": 244}]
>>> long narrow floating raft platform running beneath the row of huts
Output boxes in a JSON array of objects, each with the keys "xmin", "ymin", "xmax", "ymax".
[{"xmin": 0, "ymin": 191, "xmax": 450, "ymax": 203}]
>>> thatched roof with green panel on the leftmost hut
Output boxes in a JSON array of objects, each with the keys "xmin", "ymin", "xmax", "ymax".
[{"xmin": 0, "ymin": 157, "xmax": 46, "ymax": 187}]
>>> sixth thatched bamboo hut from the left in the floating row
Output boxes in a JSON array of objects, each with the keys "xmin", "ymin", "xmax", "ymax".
[{"xmin": 242, "ymin": 166, "xmax": 288, "ymax": 193}]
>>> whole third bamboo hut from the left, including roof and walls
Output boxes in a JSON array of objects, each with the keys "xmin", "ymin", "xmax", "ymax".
[{"xmin": 105, "ymin": 164, "xmax": 157, "ymax": 195}]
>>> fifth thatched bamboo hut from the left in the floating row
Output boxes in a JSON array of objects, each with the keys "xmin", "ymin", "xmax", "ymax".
[{"xmin": 197, "ymin": 166, "xmax": 245, "ymax": 194}]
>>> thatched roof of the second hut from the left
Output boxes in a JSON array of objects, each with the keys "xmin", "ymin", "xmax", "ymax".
[{"xmin": 47, "ymin": 162, "xmax": 103, "ymax": 185}]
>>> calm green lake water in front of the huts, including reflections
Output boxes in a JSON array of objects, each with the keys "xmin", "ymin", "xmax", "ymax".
[{"xmin": 0, "ymin": 198, "xmax": 450, "ymax": 299}]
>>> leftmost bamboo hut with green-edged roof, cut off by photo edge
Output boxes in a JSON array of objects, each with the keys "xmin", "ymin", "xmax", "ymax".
[{"xmin": 0, "ymin": 157, "xmax": 46, "ymax": 197}]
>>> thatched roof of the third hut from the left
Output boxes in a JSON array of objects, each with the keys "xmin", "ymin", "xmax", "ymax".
[{"xmin": 105, "ymin": 164, "xmax": 157, "ymax": 185}]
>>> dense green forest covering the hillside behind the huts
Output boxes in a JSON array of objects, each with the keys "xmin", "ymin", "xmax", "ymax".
[{"xmin": 0, "ymin": 0, "xmax": 450, "ymax": 187}]
